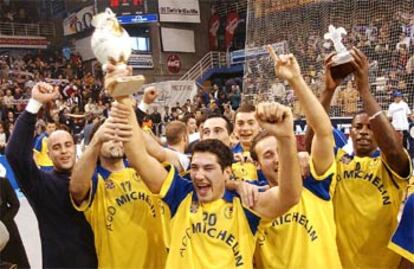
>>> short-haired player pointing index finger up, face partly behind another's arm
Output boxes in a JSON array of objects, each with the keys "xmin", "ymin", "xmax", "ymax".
[{"xmin": 250, "ymin": 47, "xmax": 341, "ymax": 269}]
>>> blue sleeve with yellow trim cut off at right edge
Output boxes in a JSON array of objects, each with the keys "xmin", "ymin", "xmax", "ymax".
[{"xmin": 388, "ymin": 185, "xmax": 414, "ymax": 263}]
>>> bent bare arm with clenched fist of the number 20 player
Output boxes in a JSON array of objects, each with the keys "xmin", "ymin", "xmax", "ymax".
[{"xmin": 252, "ymin": 103, "xmax": 302, "ymax": 219}]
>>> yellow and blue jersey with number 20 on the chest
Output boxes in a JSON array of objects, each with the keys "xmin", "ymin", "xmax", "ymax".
[{"xmin": 160, "ymin": 164, "xmax": 268, "ymax": 269}]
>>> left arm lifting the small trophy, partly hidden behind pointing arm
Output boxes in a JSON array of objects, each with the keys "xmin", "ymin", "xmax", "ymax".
[{"xmin": 305, "ymin": 53, "xmax": 343, "ymax": 153}]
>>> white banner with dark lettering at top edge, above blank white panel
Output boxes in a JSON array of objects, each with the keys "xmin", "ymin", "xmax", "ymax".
[{"xmin": 158, "ymin": 0, "xmax": 200, "ymax": 23}]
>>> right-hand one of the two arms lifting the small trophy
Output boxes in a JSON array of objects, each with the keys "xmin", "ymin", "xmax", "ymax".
[{"xmin": 351, "ymin": 48, "xmax": 411, "ymax": 178}]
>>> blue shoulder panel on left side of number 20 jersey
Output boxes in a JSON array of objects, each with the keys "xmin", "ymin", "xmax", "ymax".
[{"xmin": 163, "ymin": 172, "xmax": 194, "ymax": 218}]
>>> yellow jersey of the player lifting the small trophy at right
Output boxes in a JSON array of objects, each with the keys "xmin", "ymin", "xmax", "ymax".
[{"xmin": 333, "ymin": 149, "xmax": 412, "ymax": 268}]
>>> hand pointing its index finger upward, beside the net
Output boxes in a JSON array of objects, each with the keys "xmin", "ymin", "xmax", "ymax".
[{"xmin": 267, "ymin": 45, "xmax": 301, "ymax": 81}]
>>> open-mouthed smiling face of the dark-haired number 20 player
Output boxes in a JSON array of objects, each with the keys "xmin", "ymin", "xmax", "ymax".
[{"xmin": 190, "ymin": 152, "xmax": 231, "ymax": 203}]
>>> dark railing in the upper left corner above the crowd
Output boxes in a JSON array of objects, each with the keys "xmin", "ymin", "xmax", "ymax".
[{"xmin": 0, "ymin": 22, "xmax": 55, "ymax": 36}]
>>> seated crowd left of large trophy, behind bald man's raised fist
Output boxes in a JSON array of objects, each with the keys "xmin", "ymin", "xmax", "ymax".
[{"xmin": 0, "ymin": 48, "xmax": 111, "ymax": 152}]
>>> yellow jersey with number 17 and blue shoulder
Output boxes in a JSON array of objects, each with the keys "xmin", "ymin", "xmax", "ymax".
[{"xmin": 74, "ymin": 167, "xmax": 168, "ymax": 268}]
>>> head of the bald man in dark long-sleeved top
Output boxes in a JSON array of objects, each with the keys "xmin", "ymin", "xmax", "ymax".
[{"xmin": 47, "ymin": 130, "xmax": 76, "ymax": 171}]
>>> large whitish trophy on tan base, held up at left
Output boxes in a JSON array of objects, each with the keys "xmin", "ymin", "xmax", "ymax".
[{"xmin": 91, "ymin": 8, "xmax": 145, "ymax": 97}]
